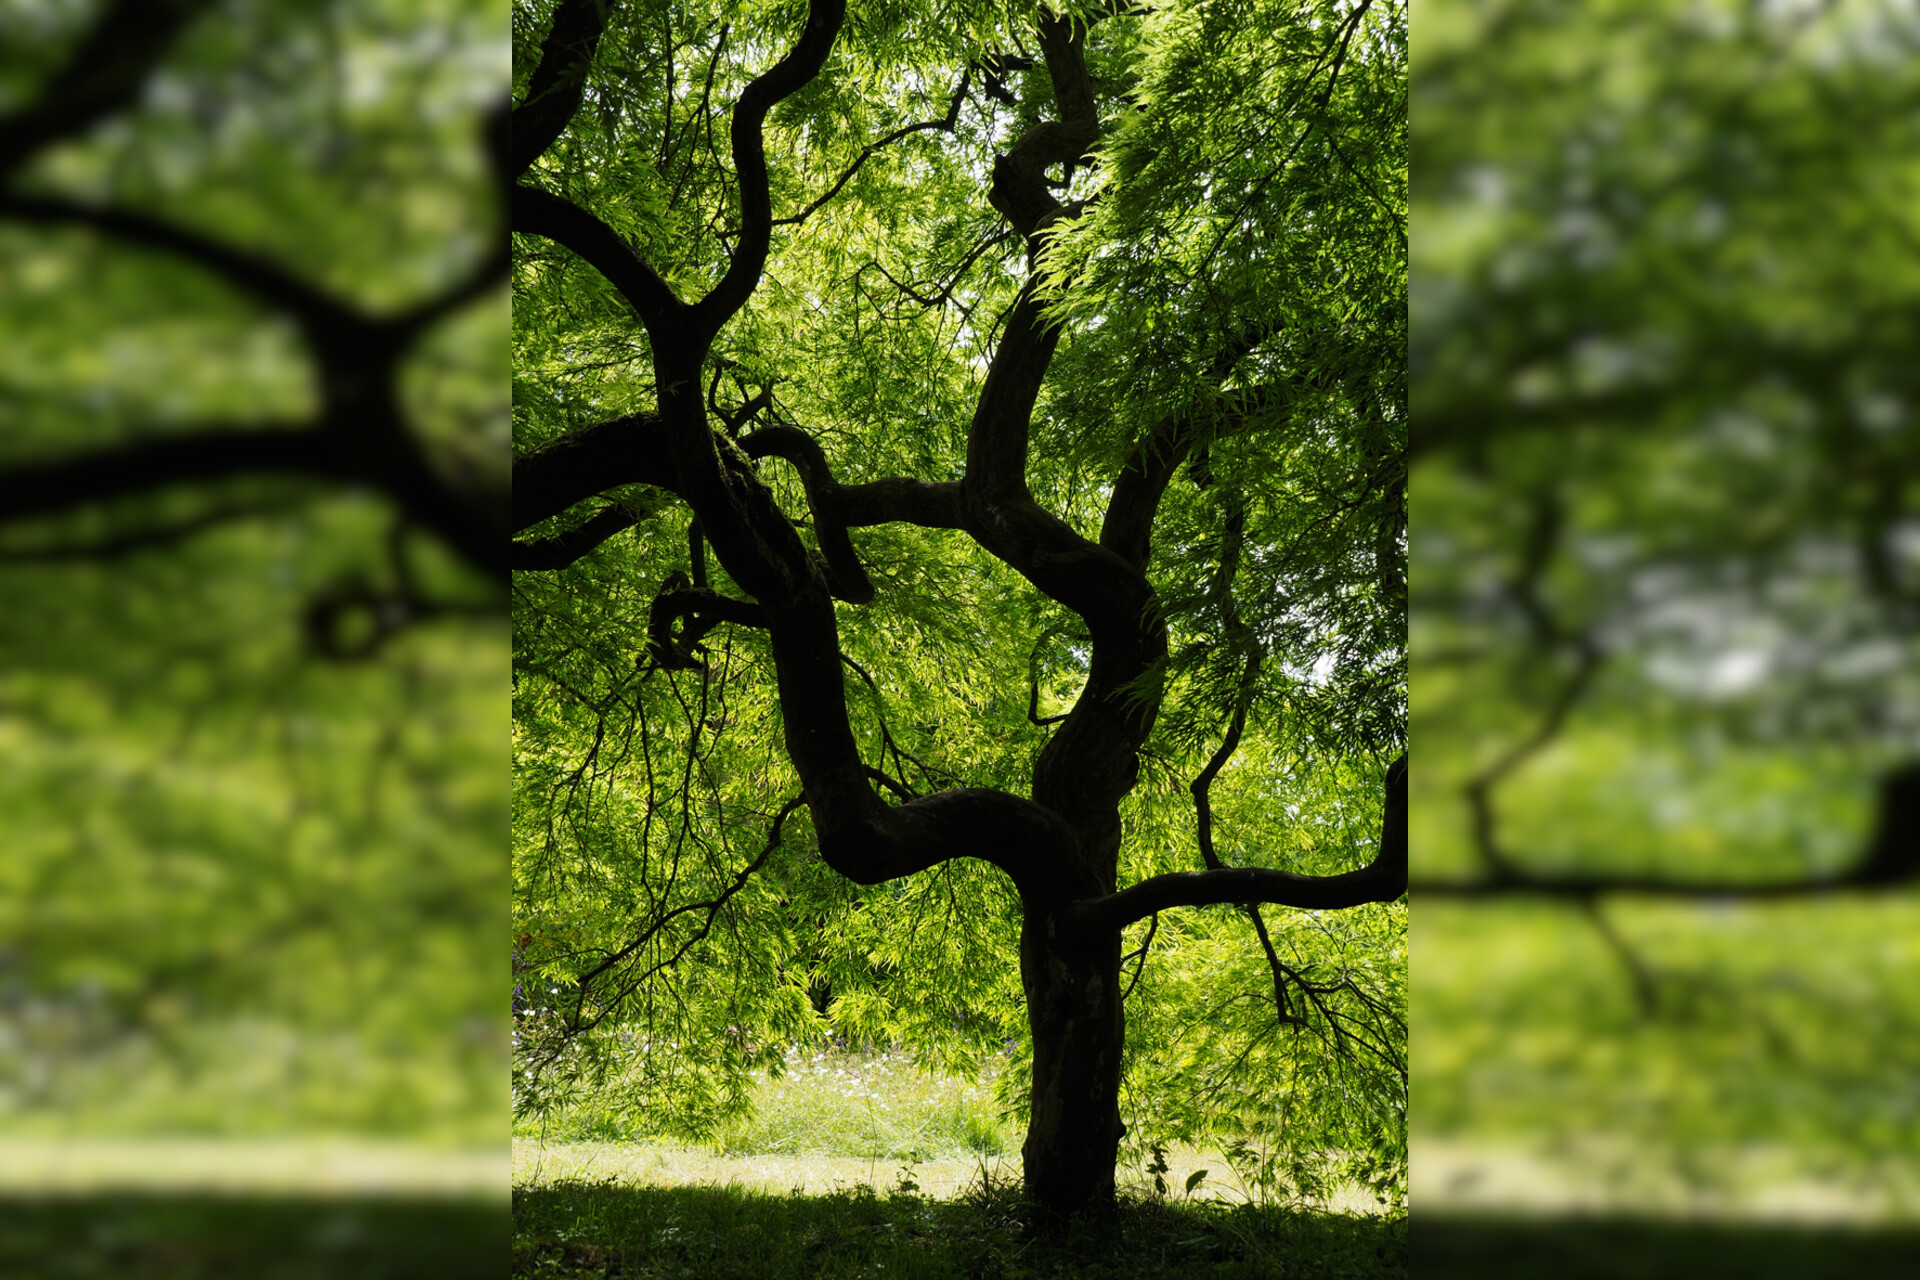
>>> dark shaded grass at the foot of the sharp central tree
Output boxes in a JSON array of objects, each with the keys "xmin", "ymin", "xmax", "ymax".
[{"xmin": 513, "ymin": 1182, "xmax": 1407, "ymax": 1280}]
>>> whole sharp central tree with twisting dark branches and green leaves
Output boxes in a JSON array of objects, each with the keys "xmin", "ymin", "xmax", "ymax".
[{"xmin": 511, "ymin": 0, "xmax": 1405, "ymax": 1217}]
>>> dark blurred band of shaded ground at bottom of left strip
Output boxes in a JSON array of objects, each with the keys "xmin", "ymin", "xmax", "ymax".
[{"xmin": 0, "ymin": 1192, "xmax": 509, "ymax": 1280}]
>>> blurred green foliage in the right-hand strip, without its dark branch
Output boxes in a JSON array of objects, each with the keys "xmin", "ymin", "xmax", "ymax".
[{"xmin": 1411, "ymin": 0, "xmax": 1920, "ymax": 1220}]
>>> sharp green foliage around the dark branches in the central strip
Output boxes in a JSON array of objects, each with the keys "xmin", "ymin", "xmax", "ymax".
[{"xmin": 515, "ymin": 2, "xmax": 1405, "ymax": 1194}]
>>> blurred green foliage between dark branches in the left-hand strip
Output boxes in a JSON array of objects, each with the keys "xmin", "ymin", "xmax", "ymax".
[{"xmin": 0, "ymin": 0, "xmax": 507, "ymax": 1142}]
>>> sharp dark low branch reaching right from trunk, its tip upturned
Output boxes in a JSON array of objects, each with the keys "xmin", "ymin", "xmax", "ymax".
[{"xmin": 1064, "ymin": 756, "xmax": 1407, "ymax": 931}]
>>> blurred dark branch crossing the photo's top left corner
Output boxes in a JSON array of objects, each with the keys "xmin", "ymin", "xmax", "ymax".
[{"xmin": 0, "ymin": 0, "xmax": 211, "ymax": 177}]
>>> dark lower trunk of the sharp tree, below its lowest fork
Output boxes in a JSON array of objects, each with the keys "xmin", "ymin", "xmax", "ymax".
[{"xmin": 1020, "ymin": 910, "xmax": 1125, "ymax": 1226}]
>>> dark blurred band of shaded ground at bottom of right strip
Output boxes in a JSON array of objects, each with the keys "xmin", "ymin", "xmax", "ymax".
[{"xmin": 1411, "ymin": 1213, "xmax": 1920, "ymax": 1280}]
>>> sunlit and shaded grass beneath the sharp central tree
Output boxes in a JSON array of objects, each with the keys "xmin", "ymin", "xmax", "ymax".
[{"xmin": 513, "ymin": 1054, "xmax": 1407, "ymax": 1280}]
